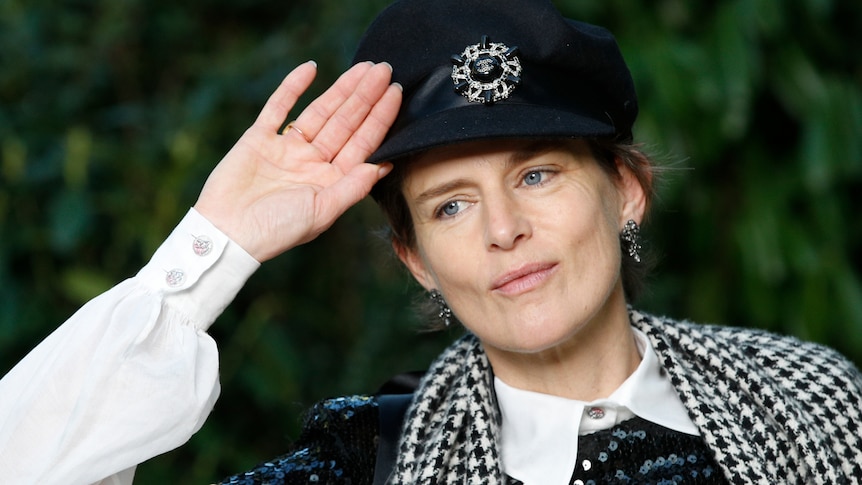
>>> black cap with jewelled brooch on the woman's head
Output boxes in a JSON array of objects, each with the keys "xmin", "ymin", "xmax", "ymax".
[{"xmin": 354, "ymin": 0, "xmax": 638, "ymax": 162}]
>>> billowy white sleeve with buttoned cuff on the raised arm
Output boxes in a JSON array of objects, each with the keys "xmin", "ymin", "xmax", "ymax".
[{"xmin": 0, "ymin": 209, "xmax": 259, "ymax": 484}]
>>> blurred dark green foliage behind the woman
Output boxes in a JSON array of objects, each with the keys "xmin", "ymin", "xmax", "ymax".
[{"xmin": 0, "ymin": 0, "xmax": 862, "ymax": 483}]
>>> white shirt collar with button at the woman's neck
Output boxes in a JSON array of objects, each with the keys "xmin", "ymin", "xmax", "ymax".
[{"xmin": 494, "ymin": 329, "xmax": 699, "ymax": 485}]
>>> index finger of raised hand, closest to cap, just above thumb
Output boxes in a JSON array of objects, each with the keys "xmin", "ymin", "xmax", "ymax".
[{"xmin": 332, "ymin": 84, "xmax": 402, "ymax": 172}]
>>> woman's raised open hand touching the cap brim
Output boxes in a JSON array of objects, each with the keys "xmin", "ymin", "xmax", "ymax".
[{"xmin": 195, "ymin": 62, "xmax": 401, "ymax": 262}]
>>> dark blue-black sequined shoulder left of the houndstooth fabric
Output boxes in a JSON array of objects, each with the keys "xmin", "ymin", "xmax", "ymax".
[{"xmin": 221, "ymin": 396, "xmax": 379, "ymax": 485}]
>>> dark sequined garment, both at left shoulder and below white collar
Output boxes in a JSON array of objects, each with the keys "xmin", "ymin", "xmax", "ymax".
[{"xmin": 222, "ymin": 396, "xmax": 727, "ymax": 485}]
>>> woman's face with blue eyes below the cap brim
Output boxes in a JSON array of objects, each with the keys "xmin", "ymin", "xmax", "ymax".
[{"xmin": 396, "ymin": 140, "xmax": 644, "ymax": 353}]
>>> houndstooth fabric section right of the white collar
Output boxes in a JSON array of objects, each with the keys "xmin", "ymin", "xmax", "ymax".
[{"xmin": 631, "ymin": 312, "xmax": 862, "ymax": 484}]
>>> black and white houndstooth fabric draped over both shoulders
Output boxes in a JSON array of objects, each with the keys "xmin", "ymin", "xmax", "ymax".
[{"xmin": 391, "ymin": 311, "xmax": 862, "ymax": 484}]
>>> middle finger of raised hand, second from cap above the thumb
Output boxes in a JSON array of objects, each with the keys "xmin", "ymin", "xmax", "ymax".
[{"xmin": 315, "ymin": 63, "xmax": 392, "ymax": 160}]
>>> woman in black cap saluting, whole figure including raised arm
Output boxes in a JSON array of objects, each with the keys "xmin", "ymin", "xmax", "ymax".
[{"xmin": 0, "ymin": 0, "xmax": 862, "ymax": 484}]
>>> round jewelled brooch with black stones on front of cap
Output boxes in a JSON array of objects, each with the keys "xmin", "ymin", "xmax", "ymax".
[{"xmin": 452, "ymin": 35, "xmax": 521, "ymax": 105}]
